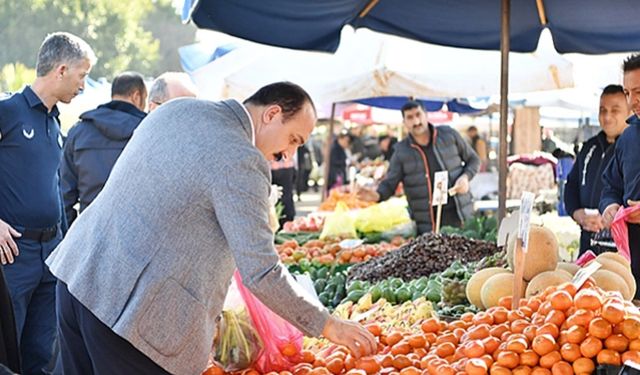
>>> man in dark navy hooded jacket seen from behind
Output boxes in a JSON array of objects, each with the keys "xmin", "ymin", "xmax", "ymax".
[{"xmin": 60, "ymin": 72, "xmax": 147, "ymax": 225}]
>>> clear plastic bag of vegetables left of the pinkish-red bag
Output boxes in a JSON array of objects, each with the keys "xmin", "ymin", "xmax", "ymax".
[{"xmin": 213, "ymin": 283, "xmax": 263, "ymax": 372}]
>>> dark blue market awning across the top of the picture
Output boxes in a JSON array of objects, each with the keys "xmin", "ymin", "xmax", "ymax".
[{"xmin": 182, "ymin": 0, "xmax": 640, "ymax": 54}]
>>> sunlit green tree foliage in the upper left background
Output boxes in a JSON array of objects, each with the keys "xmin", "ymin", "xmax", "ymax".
[{"xmin": 0, "ymin": 0, "xmax": 195, "ymax": 80}]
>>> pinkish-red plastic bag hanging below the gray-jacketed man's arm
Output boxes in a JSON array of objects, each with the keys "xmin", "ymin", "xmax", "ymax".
[{"xmin": 233, "ymin": 270, "xmax": 304, "ymax": 374}]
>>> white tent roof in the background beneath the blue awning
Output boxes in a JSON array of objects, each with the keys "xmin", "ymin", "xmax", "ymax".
[{"xmin": 192, "ymin": 29, "xmax": 573, "ymax": 106}]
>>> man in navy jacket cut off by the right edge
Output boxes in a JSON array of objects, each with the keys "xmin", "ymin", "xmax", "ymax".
[{"xmin": 600, "ymin": 54, "xmax": 640, "ymax": 299}]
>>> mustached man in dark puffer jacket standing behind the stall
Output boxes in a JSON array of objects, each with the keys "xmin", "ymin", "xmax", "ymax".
[{"xmin": 358, "ymin": 101, "xmax": 480, "ymax": 234}]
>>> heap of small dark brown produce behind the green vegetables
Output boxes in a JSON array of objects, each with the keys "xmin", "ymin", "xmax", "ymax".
[{"xmin": 349, "ymin": 233, "xmax": 498, "ymax": 282}]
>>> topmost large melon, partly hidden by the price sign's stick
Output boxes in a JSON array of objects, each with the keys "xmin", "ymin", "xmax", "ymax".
[{"xmin": 507, "ymin": 225, "xmax": 558, "ymax": 281}]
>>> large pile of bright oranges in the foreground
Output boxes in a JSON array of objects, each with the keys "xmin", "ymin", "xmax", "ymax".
[{"xmin": 202, "ymin": 280, "xmax": 640, "ymax": 375}]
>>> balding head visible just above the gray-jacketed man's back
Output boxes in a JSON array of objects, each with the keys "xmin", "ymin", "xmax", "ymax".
[{"xmin": 148, "ymin": 72, "xmax": 197, "ymax": 113}]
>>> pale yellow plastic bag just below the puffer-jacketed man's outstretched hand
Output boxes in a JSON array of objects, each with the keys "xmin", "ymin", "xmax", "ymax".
[{"xmin": 356, "ymin": 198, "xmax": 411, "ymax": 233}]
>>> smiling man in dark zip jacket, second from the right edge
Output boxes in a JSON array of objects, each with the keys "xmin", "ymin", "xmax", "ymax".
[{"xmin": 564, "ymin": 85, "xmax": 631, "ymax": 255}]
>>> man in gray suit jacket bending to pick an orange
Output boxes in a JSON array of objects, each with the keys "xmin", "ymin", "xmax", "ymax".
[{"xmin": 47, "ymin": 82, "xmax": 375, "ymax": 374}]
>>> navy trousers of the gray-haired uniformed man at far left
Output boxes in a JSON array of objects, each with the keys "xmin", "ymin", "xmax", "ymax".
[{"xmin": 3, "ymin": 235, "xmax": 62, "ymax": 375}]
